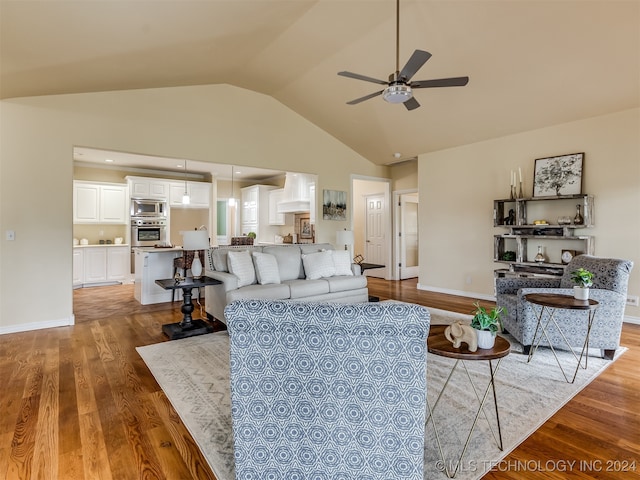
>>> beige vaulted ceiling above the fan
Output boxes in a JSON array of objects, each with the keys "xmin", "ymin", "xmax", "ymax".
[{"xmin": 0, "ymin": 0, "xmax": 640, "ymax": 164}]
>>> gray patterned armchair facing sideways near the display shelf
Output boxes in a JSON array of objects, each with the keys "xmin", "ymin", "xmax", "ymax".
[{"xmin": 496, "ymin": 255, "xmax": 633, "ymax": 359}]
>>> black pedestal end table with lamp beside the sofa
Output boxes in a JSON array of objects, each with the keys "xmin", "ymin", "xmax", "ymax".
[{"xmin": 156, "ymin": 277, "xmax": 222, "ymax": 340}]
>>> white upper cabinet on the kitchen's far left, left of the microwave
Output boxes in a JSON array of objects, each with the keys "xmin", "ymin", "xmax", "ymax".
[{"xmin": 73, "ymin": 181, "xmax": 129, "ymax": 224}]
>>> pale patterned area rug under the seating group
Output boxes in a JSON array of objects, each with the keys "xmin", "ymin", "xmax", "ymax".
[{"xmin": 137, "ymin": 309, "xmax": 625, "ymax": 480}]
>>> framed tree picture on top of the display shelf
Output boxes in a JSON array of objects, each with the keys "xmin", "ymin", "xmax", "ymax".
[{"xmin": 533, "ymin": 153, "xmax": 584, "ymax": 198}]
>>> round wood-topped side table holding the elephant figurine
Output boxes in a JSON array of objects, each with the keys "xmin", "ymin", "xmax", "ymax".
[{"xmin": 425, "ymin": 325, "xmax": 511, "ymax": 478}]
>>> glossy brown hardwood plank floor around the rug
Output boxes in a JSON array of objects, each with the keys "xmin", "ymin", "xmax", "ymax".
[{"xmin": 0, "ymin": 278, "xmax": 640, "ymax": 480}]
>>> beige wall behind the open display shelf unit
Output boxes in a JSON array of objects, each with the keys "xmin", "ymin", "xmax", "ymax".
[{"xmin": 418, "ymin": 109, "xmax": 640, "ymax": 317}]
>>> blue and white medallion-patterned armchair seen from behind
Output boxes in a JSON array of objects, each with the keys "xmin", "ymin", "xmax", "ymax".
[{"xmin": 225, "ymin": 300, "xmax": 430, "ymax": 480}]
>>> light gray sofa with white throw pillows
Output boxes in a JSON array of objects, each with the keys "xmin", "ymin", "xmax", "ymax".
[{"xmin": 205, "ymin": 243, "xmax": 369, "ymax": 323}]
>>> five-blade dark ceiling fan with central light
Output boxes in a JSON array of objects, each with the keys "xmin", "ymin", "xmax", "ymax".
[{"xmin": 338, "ymin": 0, "xmax": 469, "ymax": 110}]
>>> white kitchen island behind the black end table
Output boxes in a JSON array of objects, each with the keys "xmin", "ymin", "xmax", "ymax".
[{"xmin": 133, "ymin": 247, "xmax": 183, "ymax": 305}]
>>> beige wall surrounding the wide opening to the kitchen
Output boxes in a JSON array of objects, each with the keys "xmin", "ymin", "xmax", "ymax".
[{"xmin": 0, "ymin": 85, "xmax": 387, "ymax": 333}]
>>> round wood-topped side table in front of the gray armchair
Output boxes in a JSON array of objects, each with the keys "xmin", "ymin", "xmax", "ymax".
[{"xmin": 524, "ymin": 293, "xmax": 599, "ymax": 383}]
